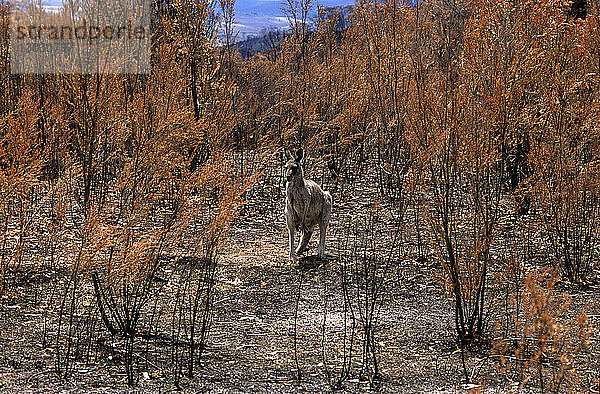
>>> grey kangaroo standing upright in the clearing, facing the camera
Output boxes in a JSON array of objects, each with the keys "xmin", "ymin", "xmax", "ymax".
[{"xmin": 285, "ymin": 149, "xmax": 332, "ymax": 262}]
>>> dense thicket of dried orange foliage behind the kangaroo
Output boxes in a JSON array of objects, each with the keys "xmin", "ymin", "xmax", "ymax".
[{"xmin": 0, "ymin": 0, "xmax": 600, "ymax": 388}]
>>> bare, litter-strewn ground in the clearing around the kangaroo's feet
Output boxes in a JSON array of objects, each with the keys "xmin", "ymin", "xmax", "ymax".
[{"xmin": 0, "ymin": 165, "xmax": 600, "ymax": 393}]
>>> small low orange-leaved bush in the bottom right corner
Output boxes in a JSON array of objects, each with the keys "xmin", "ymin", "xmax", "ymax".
[{"xmin": 494, "ymin": 270, "xmax": 593, "ymax": 392}]
